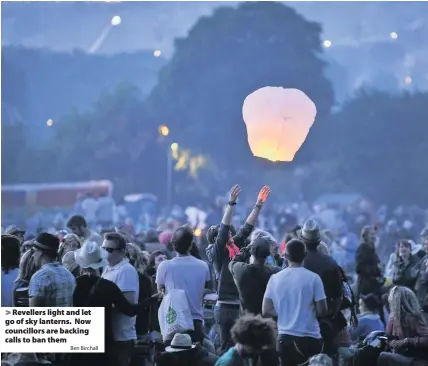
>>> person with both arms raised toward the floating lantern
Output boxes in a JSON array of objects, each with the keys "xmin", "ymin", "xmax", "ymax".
[{"xmin": 206, "ymin": 185, "xmax": 270, "ymax": 353}]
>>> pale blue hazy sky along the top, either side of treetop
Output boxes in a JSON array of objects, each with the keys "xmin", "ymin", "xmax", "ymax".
[{"xmin": 1, "ymin": 2, "xmax": 428, "ymax": 55}]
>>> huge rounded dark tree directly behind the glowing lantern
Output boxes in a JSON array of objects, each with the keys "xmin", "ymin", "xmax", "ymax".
[{"xmin": 147, "ymin": 2, "xmax": 334, "ymax": 183}]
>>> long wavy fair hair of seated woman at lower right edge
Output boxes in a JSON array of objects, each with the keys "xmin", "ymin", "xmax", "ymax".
[{"xmin": 388, "ymin": 286, "xmax": 426, "ymax": 335}]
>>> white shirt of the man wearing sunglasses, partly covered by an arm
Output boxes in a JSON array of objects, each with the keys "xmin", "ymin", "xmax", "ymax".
[{"xmin": 102, "ymin": 259, "xmax": 139, "ymax": 341}]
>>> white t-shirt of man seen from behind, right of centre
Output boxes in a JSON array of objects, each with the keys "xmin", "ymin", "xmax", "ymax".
[{"xmin": 264, "ymin": 267, "xmax": 326, "ymax": 339}]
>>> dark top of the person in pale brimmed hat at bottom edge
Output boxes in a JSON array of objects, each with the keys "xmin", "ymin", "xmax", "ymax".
[{"xmin": 155, "ymin": 345, "xmax": 217, "ymax": 366}]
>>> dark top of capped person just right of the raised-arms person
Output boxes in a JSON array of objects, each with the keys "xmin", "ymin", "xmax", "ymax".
[{"xmin": 229, "ymin": 248, "xmax": 281, "ymax": 315}]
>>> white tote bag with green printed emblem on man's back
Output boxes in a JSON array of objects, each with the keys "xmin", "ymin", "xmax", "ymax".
[{"xmin": 158, "ymin": 289, "xmax": 194, "ymax": 342}]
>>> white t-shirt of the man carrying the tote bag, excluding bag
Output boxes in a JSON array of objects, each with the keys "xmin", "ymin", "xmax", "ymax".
[{"xmin": 156, "ymin": 255, "xmax": 211, "ymax": 321}]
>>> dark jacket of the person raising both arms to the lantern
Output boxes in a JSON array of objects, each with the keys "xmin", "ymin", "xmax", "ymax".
[{"xmin": 207, "ymin": 223, "xmax": 254, "ymax": 301}]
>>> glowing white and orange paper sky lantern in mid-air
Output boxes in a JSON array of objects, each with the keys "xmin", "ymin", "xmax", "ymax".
[{"xmin": 242, "ymin": 86, "xmax": 317, "ymax": 161}]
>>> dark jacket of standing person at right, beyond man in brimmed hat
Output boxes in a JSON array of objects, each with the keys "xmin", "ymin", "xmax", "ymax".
[{"xmin": 355, "ymin": 242, "xmax": 383, "ymax": 297}]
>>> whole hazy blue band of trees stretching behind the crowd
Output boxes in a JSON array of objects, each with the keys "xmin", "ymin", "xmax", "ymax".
[{"xmin": 2, "ymin": 2, "xmax": 428, "ymax": 207}]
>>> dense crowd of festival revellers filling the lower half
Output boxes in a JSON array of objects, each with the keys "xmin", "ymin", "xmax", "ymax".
[{"xmin": 1, "ymin": 185, "xmax": 428, "ymax": 366}]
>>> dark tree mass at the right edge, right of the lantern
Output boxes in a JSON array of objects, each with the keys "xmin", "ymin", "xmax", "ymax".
[{"xmin": 331, "ymin": 91, "xmax": 428, "ymax": 207}]
